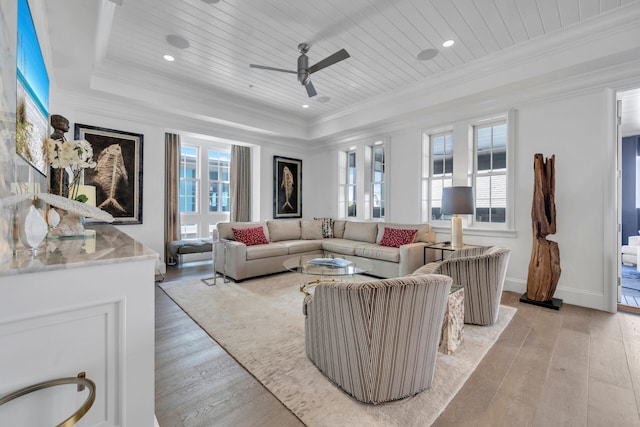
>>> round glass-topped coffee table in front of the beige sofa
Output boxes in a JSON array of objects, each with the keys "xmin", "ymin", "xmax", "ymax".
[{"xmin": 282, "ymin": 254, "xmax": 373, "ymax": 295}]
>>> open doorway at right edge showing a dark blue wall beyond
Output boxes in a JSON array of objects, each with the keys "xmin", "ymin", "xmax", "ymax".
[{"xmin": 617, "ymin": 88, "xmax": 640, "ymax": 312}]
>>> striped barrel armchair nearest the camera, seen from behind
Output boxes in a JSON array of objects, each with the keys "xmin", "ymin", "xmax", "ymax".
[{"xmin": 304, "ymin": 275, "xmax": 452, "ymax": 404}]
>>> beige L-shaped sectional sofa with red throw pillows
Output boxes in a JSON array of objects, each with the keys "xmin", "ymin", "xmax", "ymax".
[{"xmin": 214, "ymin": 219, "xmax": 435, "ymax": 281}]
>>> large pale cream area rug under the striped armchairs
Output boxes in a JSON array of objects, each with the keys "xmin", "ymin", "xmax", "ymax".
[{"xmin": 160, "ymin": 273, "xmax": 516, "ymax": 427}]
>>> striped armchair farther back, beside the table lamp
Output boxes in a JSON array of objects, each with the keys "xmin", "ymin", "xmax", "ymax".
[{"xmin": 413, "ymin": 246, "xmax": 511, "ymax": 325}]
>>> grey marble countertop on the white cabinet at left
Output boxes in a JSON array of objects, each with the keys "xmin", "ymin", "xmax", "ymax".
[{"xmin": 0, "ymin": 225, "xmax": 158, "ymax": 277}]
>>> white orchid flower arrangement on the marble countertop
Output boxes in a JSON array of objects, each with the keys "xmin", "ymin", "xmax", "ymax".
[{"xmin": 47, "ymin": 139, "xmax": 96, "ymax": 202}]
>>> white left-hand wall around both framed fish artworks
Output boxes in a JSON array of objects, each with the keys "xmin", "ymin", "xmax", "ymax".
[{"xmin": 50, "ymin": 95, "xmax": 314, "ymax": 259}]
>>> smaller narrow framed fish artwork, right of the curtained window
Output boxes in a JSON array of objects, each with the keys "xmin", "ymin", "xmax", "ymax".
[{"xmin": 273, "ymin": 156, "xmax": 302, "ymax": 219}]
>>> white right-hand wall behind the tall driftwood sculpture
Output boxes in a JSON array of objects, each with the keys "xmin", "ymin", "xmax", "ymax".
[{"xmin": 307, "ymin": 89, "xmax": 615, "ymax": 310}]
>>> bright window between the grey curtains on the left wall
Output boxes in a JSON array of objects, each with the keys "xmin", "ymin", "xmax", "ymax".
[{"xmin": 179, "ymin": 144, "xmax": 231, "ymax": 239}]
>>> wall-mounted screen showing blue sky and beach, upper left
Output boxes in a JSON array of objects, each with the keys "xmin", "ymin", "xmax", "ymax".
[{"xmin": 16, "ymin": 0, "xmax": 49, "ymax": 176}]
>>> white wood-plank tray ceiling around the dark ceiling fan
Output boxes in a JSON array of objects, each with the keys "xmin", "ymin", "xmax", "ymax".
[{"xmin": 46, "ymin": 0, "xmax": 640, "ymax": 138}]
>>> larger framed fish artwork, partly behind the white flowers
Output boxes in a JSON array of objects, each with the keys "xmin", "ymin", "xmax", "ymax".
[{"xmin": 74, "ymin": 123, "xmax": 143, "ymax": 225}]
